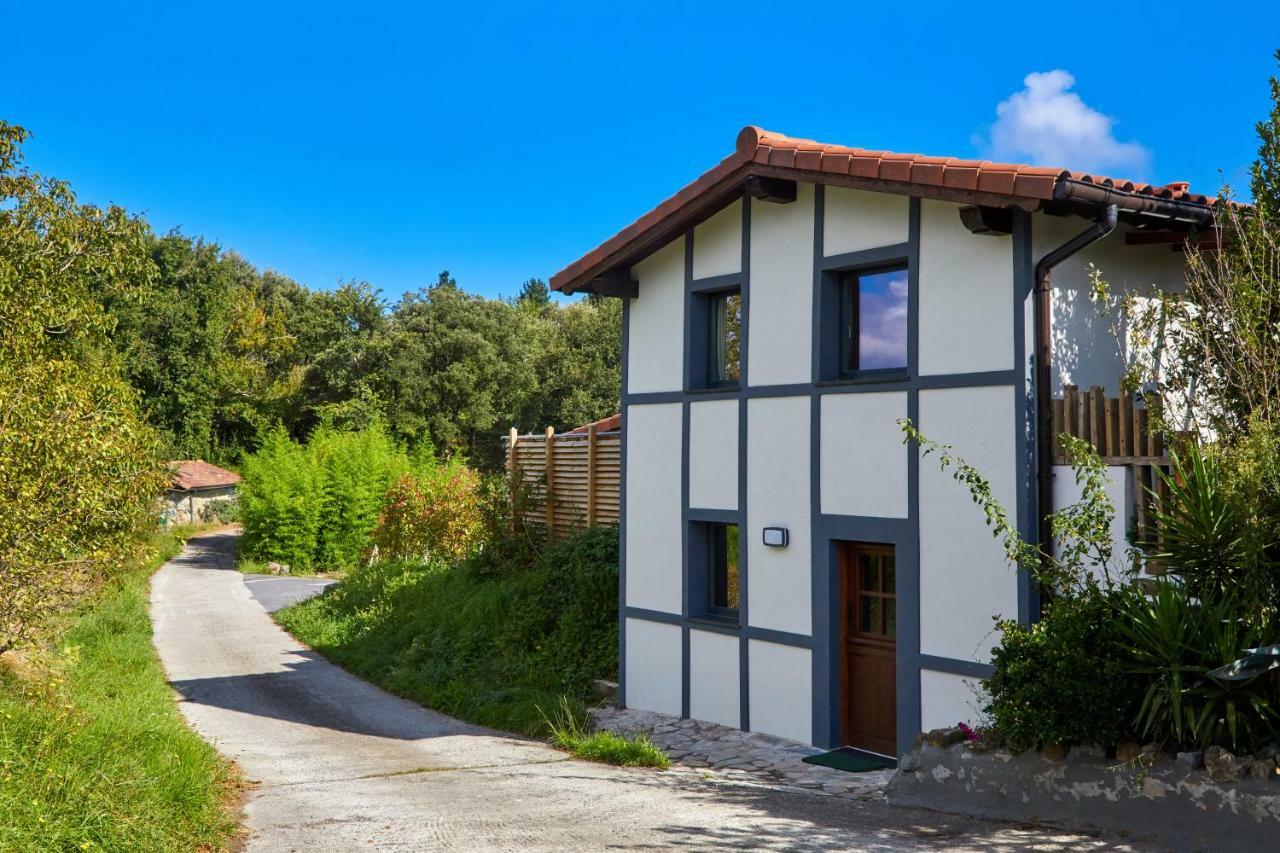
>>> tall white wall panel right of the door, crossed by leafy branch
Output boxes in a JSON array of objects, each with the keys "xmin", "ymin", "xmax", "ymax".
[{"xmin": 919, "ymin": 386, "xmax": 1018, "ymax": 661}]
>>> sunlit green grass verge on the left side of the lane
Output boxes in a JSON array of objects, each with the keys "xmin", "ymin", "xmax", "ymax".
[{"xmin": 0, "ymin": 532, "xmax": 238, "ymax": 850}]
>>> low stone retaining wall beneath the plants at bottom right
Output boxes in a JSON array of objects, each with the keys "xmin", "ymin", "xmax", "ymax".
[{"xmin": 887, "ymin": 730, "xmax": 1280, "ymax": 850}]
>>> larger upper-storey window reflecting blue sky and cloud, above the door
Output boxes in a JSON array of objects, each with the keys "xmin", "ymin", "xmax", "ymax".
[{"xmin": 840, "ymin": 266, "xmax": 908, "ymax": 377}]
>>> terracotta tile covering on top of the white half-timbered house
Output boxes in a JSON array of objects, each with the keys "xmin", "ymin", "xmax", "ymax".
[{"xmin": 550, "ymin": 126, "xmax": 1217, "ymax": 292}]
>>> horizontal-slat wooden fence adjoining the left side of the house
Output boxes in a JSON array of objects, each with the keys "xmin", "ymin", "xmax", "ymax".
[{"xmin": 503, "ymin": 427, "xmax": 622, "ymax": 535}]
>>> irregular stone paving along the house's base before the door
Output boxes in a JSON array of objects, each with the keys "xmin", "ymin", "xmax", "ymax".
[{"xmin": 590, "ymin": 706, "xmax": 893, "ymax": 799}]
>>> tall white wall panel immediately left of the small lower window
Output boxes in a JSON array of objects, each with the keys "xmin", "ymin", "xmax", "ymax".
[{"xmin": 625, "ymin": 403, "xmax": 682, "ymax": 613}]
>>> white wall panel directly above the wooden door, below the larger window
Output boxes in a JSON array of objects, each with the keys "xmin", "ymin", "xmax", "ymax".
[{"xmin": 818, "ymin": 392, "xmax": 908, "ymax": 519}]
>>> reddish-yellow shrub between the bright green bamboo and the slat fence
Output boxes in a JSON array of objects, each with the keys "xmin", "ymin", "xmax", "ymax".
[{"xmin": 372, "ymin": 462, "xmax": 484, "ymax": 560}]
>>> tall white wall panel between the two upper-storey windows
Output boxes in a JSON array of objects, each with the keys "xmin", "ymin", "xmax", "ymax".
[{"xmin": 746, "ymin": 183, "xmax": 814, "ymax": 386}]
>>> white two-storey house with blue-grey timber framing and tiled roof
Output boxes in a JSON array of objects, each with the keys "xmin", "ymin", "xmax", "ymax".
[{"xmin": 552, "ymin": 127, "xmax": 1213, "ymax": 754}]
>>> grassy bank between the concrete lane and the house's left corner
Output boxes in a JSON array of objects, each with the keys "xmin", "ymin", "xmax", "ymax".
[{"xmin": 276, "ymin": 528, "xmax": 618, "ymax": 735}]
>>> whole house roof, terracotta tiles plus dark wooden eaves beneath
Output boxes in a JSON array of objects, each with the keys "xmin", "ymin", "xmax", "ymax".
[{"xmin": 550, "ymin": 127, "xmax": 1219, "ymax": 296}]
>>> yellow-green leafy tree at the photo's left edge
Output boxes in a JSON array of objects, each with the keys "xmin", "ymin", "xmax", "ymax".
[{"xmin": 0, "ymin": 122, "xmax": 165, "ymax": 652}]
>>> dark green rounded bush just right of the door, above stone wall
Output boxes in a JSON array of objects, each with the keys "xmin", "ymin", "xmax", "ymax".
[{"xmin": 986, "ymin": 592, "xmax": 1142, "ymax": 749}]
